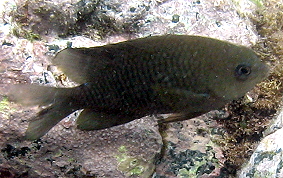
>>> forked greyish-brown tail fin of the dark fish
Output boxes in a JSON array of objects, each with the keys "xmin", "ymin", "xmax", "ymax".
[{"xmin": 0, "ymin": 84, "xmax": 80, "ymax": 140}]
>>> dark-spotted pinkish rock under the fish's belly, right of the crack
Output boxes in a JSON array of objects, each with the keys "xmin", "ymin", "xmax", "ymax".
[{"xmin": 155, "ymin": 115, "xmax": 225, "ymax": 178}]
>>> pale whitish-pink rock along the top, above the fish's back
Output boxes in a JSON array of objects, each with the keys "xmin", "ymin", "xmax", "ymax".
[{"xmin": 3, "ymin": 0, "xmax": 258, "ymax": 45}]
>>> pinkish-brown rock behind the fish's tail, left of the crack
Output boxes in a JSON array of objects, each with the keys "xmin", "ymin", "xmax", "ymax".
[{"xmin": 0, "ymin": 27, "xmax": 162, "ymax": 177}]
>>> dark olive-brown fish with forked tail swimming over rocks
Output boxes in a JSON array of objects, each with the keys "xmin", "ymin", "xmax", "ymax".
[{"xmin": 2, "ymin": 35, "xmax": 269, "ymax": 140}]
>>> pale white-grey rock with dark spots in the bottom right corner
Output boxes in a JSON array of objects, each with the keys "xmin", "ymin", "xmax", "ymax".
[{"xmin": 239, "ymin": 106, "xmax": 283, "ymax": 178}]
